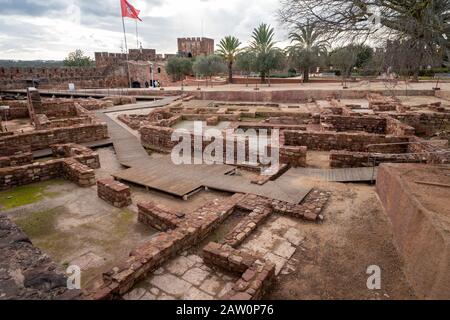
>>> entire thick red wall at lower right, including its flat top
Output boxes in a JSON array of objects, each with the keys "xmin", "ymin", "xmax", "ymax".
[{"xmin": 376, "ymin": 164, "xmax": 450, "ymax": 300}]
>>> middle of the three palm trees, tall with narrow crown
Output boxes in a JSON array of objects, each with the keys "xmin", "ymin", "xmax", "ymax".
[{"xmin": 250, "ymin": 23, "xmax": 275, "ymax": 82}]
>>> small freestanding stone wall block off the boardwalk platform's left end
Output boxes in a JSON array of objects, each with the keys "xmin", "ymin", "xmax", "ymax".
[{"xmin": 97, "ymin": 179, "xmax": 132, "ymax": 208}]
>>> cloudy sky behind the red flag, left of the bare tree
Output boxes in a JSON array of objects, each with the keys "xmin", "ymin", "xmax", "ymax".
[{"xmin": 0, "ymin": 0, "xmax": 286, "ymax": 60}]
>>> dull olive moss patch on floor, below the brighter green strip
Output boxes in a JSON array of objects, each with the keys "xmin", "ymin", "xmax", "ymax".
[{"xmin": 15, "ymin": 207, "xmax": 63, "ymax": 239}]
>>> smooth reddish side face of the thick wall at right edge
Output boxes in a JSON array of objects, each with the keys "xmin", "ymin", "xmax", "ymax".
[{"xmin": 377, "ymin": 164, "xmax": 450, "ymax": 300}]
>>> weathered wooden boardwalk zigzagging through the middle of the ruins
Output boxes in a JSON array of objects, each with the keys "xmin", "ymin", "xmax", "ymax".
[{"xmin": 97, "ymin": 98, "xmax": 311, "ymax": 203}]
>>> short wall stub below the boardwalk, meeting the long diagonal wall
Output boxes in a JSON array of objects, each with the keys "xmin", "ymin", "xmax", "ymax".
[{"xmin": 137, "ymin": 202, "xmax": 185, "ymax": 231}]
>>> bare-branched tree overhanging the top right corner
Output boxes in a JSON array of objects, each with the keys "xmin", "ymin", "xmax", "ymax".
[{"xmin": 279, "ymin": 0, "xmax": 450, "ymax": 78}]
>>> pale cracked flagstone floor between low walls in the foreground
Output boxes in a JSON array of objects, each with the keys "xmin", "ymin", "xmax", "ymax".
[{"xmin": 123, "ymin": 215, "xmax": 305, "ymax": 300}]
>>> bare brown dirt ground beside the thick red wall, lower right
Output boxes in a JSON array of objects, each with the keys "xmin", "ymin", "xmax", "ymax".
[{"xmin": 266, "ymin": 182, "xmax": 415, "ymax": 300}]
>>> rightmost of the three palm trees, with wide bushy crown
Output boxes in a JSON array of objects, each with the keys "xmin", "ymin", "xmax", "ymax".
[{"xmin": 288, "ymin": 24, "xmax": 327, "ymax": 82}]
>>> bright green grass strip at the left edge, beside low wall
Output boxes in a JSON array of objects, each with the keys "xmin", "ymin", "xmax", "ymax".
[{"xmin": 0, "ymin": 180, "xmax": 63, "ymax": 210}]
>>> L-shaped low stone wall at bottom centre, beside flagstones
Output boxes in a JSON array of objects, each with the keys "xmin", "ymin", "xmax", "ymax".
[{"xmin": 203, "ymin": 242, "xmax": 275, "ymax": 300}]
